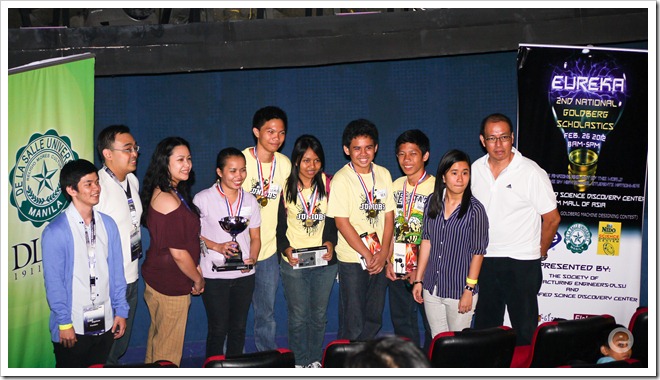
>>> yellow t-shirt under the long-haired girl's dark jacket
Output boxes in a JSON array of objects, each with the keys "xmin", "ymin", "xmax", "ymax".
[{"xmin": 283, "ymin": 174, "xmax": 328, "ymax": 262}]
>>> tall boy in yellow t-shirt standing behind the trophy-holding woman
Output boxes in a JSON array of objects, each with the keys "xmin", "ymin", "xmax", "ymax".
[{"xmin": 243, "ymin": 106, "xmax": 291, "ymax": 351}]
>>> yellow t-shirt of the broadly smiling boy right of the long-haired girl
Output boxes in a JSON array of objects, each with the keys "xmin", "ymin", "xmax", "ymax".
[{"xmin": 328, "ymin": 164, "xmax": 396, "ymax": 263}]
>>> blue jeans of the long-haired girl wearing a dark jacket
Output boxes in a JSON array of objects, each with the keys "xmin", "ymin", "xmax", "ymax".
[{"xmin": 280, "ymin": 260, "xmax": 337, "ymax": 365}]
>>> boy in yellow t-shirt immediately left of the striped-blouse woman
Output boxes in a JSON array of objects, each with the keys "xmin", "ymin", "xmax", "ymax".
[{"xmin": 386, "ymin": 129, "xmax": 435, "ymax": 351}]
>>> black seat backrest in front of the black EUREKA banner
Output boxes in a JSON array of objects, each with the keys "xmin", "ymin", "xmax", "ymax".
[{"xmin": 530, "ymin": 314, "xmax": 616, "ymax": 368}]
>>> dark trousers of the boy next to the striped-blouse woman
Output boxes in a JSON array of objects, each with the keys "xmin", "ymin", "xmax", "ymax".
[{"xmin": 388, "ymin": 280, "xmax": 432, "ymax": 351}]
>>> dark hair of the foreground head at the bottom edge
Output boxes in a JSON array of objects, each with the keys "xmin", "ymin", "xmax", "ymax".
[{"xmin": 347, "ymin": 336, "xmax": 431, "ymax": 368}]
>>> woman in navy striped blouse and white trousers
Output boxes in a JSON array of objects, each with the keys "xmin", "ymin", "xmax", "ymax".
[{"xmin": 413, "ymin": 149, "xmax": 488, "ymax": 336}]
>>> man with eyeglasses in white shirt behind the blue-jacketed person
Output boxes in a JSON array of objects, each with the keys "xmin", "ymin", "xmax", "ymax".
[{"xmin": 96, "ymin": 125, "xmax": 142, "ymax": 365}]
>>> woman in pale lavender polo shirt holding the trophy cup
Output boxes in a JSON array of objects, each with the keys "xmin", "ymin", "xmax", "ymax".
[{"xmin": 193, "ymin": 148, "xmax": 261, "ymax": 357}]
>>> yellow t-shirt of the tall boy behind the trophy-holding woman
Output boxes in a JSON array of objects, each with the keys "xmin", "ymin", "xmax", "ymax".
[{"xmin": 243, "ymin": 147, "xmax": 291, "ymax": 261}]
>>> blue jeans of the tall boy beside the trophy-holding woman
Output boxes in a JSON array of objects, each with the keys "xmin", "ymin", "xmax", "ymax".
[{"xmin": 252, "ymin": 253, "xmax": 280, "ymax": 351}]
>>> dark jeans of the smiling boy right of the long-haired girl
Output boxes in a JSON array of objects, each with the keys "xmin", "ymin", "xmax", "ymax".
[{"xmin": 337, "ymin": 262, "xmax": 389, "ymax": 340}]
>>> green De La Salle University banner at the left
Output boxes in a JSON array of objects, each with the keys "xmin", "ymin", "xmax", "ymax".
[{"xmin": 6, "ymin": 54, "xmax": 94, "ymax": 368}]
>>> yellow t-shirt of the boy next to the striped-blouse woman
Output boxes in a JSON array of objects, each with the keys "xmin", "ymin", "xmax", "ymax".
[{"xmin": 393, "ymin": 175, "xmax": 435, "ymax": 245}]
